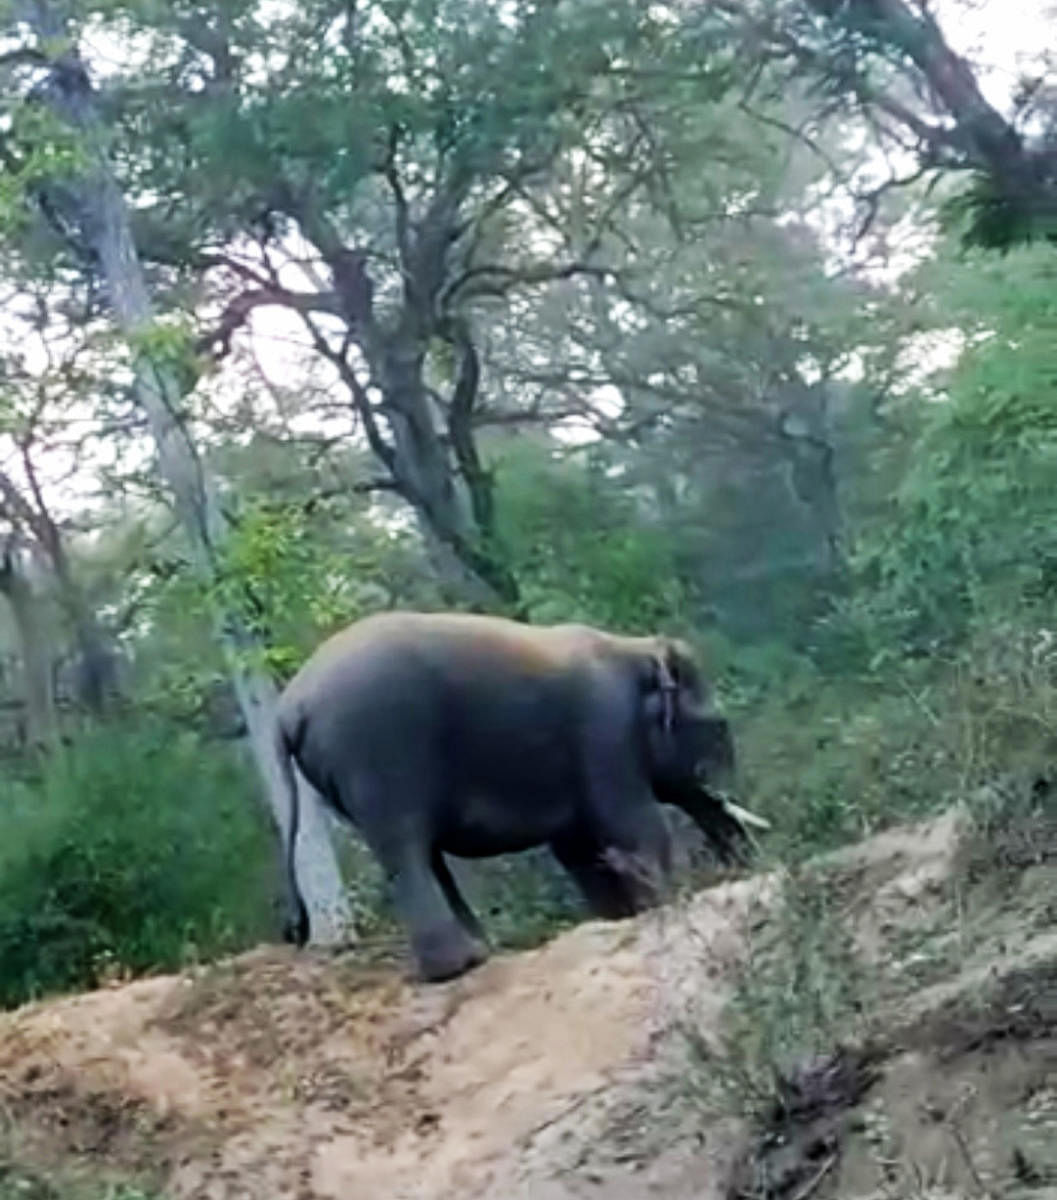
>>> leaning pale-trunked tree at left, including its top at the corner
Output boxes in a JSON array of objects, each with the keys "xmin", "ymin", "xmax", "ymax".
[{"xmin": 5, "ymin": 2, "xmax": 348, "ymax": 940}]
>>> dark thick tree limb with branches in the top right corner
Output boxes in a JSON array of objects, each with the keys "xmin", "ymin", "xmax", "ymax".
[{"xmin": 709, "ymin": 0, "xmax": 1057, "ymax": 248}]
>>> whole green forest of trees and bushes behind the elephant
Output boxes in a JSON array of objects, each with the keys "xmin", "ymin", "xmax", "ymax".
[{"xmin": 0, "ymin": 0, "xmax": 1057, "ymax": 1004}]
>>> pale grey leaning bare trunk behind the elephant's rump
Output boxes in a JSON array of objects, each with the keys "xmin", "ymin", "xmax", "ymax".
[{"xmin": 26, "ymin": 16, "xmax": 352, "ymax": 943}]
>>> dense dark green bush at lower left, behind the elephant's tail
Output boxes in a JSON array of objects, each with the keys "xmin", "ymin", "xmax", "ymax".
[{"xmin": 0, "ymin": 726, "xmax": 277, "ymax": 1006}]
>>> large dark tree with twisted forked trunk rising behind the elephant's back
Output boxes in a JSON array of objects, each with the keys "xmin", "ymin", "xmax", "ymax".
[{"xmin": 55, "ymin": 0, "xmax": 734, "ymax": 611}]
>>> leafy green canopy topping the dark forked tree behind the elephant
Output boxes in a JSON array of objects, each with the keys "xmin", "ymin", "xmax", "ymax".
[{"xmin": 97, "ymin": 0, "xmax": 676, "ymax": 255}]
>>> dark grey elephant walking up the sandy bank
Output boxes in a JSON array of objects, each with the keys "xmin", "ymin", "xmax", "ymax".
[{"xmin": 277, "ymin": 612, "xmax": 748, "ymax": 980}]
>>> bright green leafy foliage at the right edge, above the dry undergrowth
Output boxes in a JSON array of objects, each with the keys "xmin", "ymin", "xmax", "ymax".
[{"xmin": 846, "ymin": 243, "xmax": 1057, "ymax": 661}]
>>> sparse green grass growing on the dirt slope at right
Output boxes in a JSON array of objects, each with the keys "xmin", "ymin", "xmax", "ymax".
[{"xmin": 672, "ymin": 734, "xmax": 1057, "ymax": 1156}]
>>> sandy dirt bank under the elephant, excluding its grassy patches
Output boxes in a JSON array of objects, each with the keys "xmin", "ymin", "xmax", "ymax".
[{"xmin": 0, "ymin": 816, "xmax": 1057, "ymax": 1200}]
